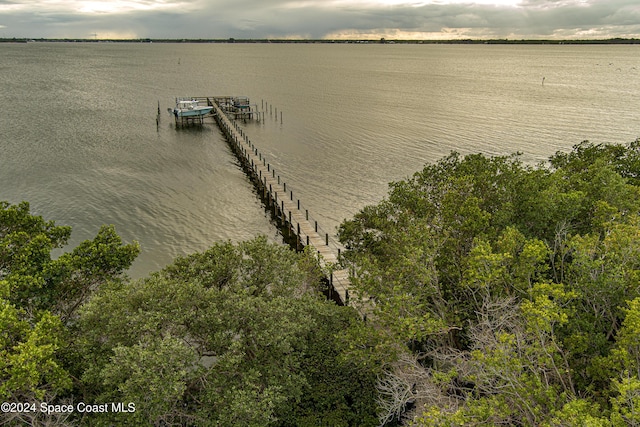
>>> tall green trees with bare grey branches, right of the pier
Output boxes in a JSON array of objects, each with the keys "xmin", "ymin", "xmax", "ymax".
[{"xmin": 340, "ymin": 140, "xmax": 640, "ymax": 426}]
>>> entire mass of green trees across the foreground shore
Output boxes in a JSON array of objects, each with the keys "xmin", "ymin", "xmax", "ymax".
[{"xmin": 0, "ymin": 140, "xmax": 640, "ymax": 427}]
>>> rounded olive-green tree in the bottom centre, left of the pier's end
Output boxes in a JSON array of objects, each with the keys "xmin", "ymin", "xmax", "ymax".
[{"xmin": 79, "ymin": 238, "xmax": 374, "ymax": 426}]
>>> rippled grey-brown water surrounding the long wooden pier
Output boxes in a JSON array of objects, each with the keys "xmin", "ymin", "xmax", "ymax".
[{"xmin": 0, "ymin": 43, "xmax": 640, "ymax": 277}]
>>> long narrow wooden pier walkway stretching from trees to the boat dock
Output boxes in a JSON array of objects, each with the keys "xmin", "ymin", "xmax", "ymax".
[{"xmin": 205, "ymin": 96, "xmax": 356, "ymax": 305}]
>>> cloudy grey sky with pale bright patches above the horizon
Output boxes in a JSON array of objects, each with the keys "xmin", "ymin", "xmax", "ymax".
[{"xmin": 0, "ymin": 0, "xmax": 640, "ymax": 40}]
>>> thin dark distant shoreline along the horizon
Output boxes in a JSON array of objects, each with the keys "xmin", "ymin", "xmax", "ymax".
[{"xmin": 5, "ymin": 37, "xmax": 640, "ymax": 45}]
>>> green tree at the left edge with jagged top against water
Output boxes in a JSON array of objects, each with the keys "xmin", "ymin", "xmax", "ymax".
[{"xmin": 0, "ymin": 202, "xmax": 138, "ymax": 410}]
